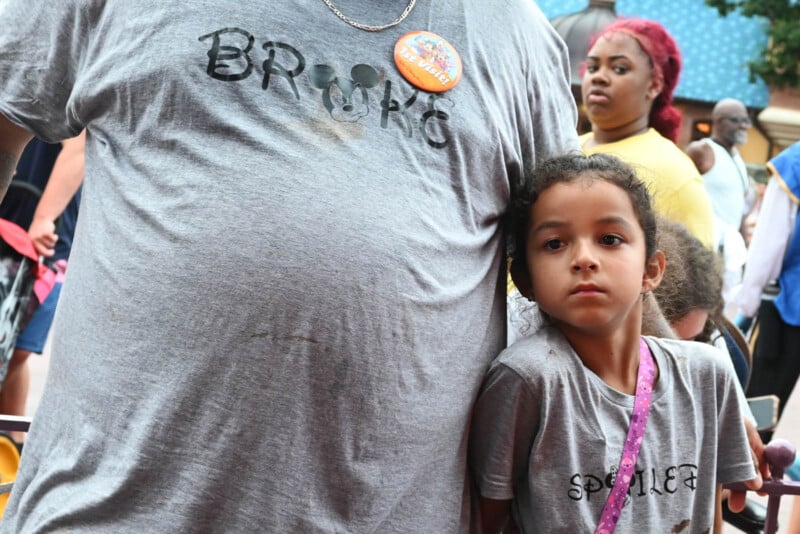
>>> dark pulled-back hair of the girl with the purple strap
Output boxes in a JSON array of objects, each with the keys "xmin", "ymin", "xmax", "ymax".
[{"xmin": 511, "ymin": 153, "xmax": 656, "ymax": 271}]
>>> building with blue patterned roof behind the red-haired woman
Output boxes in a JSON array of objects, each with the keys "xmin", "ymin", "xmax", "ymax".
[{"xmin": 536, "ymin": 0, "xmax": 800, "ymax": 163}]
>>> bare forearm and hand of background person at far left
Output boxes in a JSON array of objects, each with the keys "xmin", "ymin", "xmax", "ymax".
[{"xmin": 28, "ymin": 131, "xmax": 86, "ymax": 257}]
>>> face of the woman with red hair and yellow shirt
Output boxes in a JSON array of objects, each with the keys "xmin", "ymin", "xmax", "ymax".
[{"xmin": 581, "ymin": 32, "xmax": 662, "ymax": 134}]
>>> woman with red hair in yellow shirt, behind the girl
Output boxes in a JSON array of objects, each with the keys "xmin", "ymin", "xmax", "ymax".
[{"xmin": 580, "ymin": 19, "xmax": 714, "ymax": 247}]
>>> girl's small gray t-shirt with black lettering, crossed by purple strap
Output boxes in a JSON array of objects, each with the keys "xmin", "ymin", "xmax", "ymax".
[{"xmin": 470, "ymin": 326, "xmax": 755, "ymax": 533}]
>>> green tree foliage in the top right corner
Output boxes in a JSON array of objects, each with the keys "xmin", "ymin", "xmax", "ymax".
[{"xmin": 705, "ymin": 0, "xmax": 800, "ymax": 88}]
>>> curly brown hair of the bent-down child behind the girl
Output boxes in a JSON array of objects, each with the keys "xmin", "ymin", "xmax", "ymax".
[{"xmin": 653, "ymin": 217, "xmax": 724, "ymax": 342}]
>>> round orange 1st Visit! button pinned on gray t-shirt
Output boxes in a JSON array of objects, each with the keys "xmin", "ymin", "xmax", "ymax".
[{"xmin": 394, "ymin": 31, "xmax": 462, "ymax": 93}]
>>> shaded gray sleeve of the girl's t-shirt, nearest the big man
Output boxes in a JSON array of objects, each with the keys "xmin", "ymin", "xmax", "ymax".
[{"xmin": 469, "ymin": 364, "xmax": 538, "ymax": 500}]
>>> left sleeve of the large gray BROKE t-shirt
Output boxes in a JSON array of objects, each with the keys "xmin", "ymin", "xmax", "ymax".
[{"xmin": 0, "ymin": 0, "xmax": 86, "ymax": 142}]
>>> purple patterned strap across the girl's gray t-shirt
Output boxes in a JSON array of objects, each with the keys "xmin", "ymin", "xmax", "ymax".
[{"xmin": 595, "ymin": 338, "xmax": 656, "ymax": 534}]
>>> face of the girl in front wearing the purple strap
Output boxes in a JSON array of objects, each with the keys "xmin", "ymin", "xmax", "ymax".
[{"xmin": 526, "ymin": 180, "xmax": 664, "ymax": 340}]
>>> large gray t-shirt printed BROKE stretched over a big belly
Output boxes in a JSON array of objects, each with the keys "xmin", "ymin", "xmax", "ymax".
[{"xmin": 0, "ymin": 0, "xmax": 577, "ymax": 534}]
